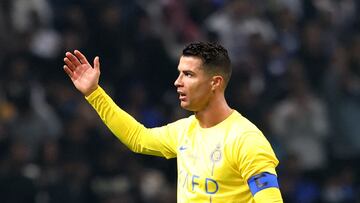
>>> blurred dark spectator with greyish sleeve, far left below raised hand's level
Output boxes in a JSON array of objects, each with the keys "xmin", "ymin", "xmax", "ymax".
[{"xmin": 4, "ymin": 57, "xmax": 62, "ymax": 158}]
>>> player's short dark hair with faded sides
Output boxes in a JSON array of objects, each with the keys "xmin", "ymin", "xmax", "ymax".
[{"xmin": 182, "ymin": 42, "xmax": 232, "ymax": 87}]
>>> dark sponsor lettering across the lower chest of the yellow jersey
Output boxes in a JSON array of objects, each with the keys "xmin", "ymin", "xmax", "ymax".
[{"xmin": 179, "ymin": 173, "xmax": 219, "ymax": 194}]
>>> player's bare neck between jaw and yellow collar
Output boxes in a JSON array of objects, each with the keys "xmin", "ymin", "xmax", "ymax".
[{"xmin": 195, "ymin": 93, "xmax": 233, "ymax": 128}]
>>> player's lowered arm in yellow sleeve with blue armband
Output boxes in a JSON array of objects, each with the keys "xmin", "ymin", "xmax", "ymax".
[{"xmin": 233, "ymin": 131, "xmax": 282, "ymax": 200}]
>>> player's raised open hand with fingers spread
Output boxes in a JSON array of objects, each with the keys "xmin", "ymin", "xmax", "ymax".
[{"xmin": 64, "ymin": 50, "xmax": 100, "ymax": 96}]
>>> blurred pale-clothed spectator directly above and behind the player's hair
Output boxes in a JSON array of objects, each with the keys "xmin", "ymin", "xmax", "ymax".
[{"xmin": 205, "ymin": 0, "xmax": 276, "ymax": 65}]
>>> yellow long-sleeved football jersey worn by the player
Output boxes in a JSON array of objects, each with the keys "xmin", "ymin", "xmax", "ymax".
[{"xmin": 86, "ymin": 87, "xmax": 282, "ymax": 203}]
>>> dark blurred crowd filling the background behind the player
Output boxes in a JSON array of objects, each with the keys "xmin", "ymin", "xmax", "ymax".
[{"xmin": 0, "ymin": 0, "xmax": 360, "ymax": 203}]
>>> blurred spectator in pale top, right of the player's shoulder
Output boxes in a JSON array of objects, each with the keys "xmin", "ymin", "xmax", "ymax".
[{"xmin": 272, "ymin": 61, "xmax": 329, "ymax": 171}]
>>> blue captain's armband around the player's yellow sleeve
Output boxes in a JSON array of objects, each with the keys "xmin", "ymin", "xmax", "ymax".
[{"xmin": 248, "ymin": 172, "xmax": 279, "ymax": 196}]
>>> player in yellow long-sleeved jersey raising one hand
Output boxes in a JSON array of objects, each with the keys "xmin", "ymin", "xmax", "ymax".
[{"xmin": 64, "ymin": 42, "xmax": 282, "ymax": 203}]
